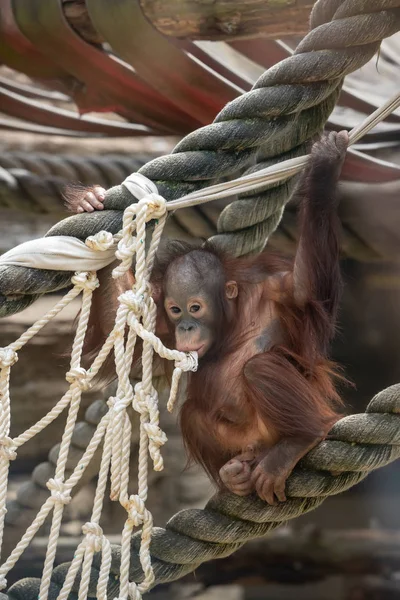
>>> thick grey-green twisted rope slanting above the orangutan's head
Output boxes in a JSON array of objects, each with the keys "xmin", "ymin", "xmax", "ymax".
[{"xmin": 0, "ymin": 0, "xmax": 400, "ymax": 316}]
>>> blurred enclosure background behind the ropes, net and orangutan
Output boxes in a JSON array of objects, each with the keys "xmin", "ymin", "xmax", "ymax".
[{"xmin": 0, "ymin": 0, "xmax": 400, "ymax": 600}]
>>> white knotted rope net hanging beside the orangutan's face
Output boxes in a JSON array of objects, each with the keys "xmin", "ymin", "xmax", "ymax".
[{"xmin": 0, "ymin": 185, "xmax": 197, "ymax": 600}]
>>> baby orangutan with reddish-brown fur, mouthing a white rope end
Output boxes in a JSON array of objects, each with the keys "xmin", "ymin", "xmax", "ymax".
[{"xmin": 67, "ymin": 132, "xmax": 348, "ymax": 504}]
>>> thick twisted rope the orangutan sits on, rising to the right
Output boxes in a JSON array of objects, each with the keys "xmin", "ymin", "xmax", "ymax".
[{"xmin": 5, "ymin": 384, "xmax": 400, "ymax": 600}]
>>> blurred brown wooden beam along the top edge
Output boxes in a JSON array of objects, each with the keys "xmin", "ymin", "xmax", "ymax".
[{"xmin": 62, "ymin": 0, "xmax": 315, "ymax": 45}]
